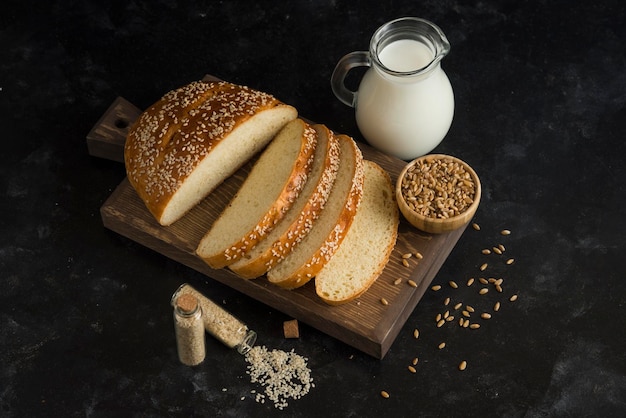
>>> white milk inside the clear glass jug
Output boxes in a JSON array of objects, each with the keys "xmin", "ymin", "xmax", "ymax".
[{"xmin": 356, "ymin": 39, "xmax": 454, "ymax": 160}]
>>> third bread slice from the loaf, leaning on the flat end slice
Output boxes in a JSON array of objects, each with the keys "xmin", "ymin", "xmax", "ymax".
[{"xmin": 267, "ymin": 135, "xmax": 363, "ymax": 289}]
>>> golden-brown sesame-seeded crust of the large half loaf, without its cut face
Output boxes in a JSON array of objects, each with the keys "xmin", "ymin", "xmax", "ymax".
[{"xmin": 124, "ymin": 81, "xmax": 295, "ymax": 225}]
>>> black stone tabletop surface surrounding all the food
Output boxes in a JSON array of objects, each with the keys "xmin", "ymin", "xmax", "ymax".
[{"xmin": 0, "ymin": 0, "xmax": 626, "ymax": 417}]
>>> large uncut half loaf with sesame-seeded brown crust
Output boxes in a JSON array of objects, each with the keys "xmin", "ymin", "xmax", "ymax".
[{"xmin": 124, "ymin": 81, "xmax": 298, "ymax": 225}]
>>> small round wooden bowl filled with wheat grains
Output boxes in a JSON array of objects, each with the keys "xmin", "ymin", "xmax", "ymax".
[{"xmin": 396, "ymin": 154, "xmax": 481, "ymax": 234}]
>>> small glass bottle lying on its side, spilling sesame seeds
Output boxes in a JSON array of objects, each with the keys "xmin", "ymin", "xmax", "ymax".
[{"xmin": 172, "ymin": 283, "xmax": 257, "ymax": 354}]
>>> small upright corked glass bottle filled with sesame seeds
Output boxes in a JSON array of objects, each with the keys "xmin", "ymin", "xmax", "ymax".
[{"xmin": 174, "ymin": 294, "xmax": 206, "ymax": 366}]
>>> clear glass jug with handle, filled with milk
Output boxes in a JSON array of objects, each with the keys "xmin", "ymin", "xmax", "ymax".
[{"xmin": 331, "ymin": 17, "xmax": 454, "ymax": 160}]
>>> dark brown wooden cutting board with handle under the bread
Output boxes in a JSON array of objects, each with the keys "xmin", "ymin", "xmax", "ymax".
[{"xmin": 87, "ymin": 76, "xmax": 465, "ymax": 359}]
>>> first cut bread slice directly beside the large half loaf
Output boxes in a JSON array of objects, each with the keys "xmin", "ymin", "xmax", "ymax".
[{"xmin": 196, "ymin": 119, "xmax": 317, "ymax": 268}]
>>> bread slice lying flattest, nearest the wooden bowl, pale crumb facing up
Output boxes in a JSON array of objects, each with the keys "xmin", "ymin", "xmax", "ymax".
[{"xmin": 315, "ymin": 161, "xmax": 399, "ymax": 305}]
